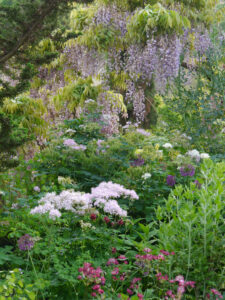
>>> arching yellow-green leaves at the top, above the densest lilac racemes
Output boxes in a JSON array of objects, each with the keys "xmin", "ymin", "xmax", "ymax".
[{"xmin": 128, "ymin": 3, "xmax": 190, "ymax": 42}]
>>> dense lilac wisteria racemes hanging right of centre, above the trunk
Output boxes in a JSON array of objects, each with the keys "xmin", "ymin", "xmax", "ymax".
[{"xmin": 126, "ymin": 34, "xmax": 182, "ymax": 88}]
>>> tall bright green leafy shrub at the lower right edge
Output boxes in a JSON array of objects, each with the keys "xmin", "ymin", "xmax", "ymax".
[{"xmin": 157, "ymin": 160, "xmax": 225, "ymax": 299}]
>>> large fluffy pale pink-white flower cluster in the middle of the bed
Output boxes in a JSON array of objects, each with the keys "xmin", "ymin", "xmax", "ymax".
[{"xmin": 30, "ymin": 181, "xmax": 138, "ymax": 220}]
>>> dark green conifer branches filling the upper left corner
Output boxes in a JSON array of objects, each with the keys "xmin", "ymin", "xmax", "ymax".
[{"xmin": 0, "ymin": 0, "xmax": 92, "ymax": 170}]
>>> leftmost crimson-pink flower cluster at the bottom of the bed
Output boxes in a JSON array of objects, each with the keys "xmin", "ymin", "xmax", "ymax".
[{"xmin": 77, "ymin": 263, "xmax": 105, "ymax": 297}]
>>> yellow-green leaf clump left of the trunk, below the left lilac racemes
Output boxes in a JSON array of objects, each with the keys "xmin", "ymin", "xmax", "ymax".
[{"xmin": 53, "ymin": 77, "xmax": 101, "ymax": 112}]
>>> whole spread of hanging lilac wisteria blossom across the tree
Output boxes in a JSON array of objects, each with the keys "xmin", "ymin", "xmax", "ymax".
[{"xmin": 31, "ymin": 3, "xmax": 213, "ymax": 129}]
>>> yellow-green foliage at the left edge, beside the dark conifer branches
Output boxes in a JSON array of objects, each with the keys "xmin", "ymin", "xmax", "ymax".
[{"xmin": 1, "ymin": 95, "xmax": 47, "ymax": 135}]
